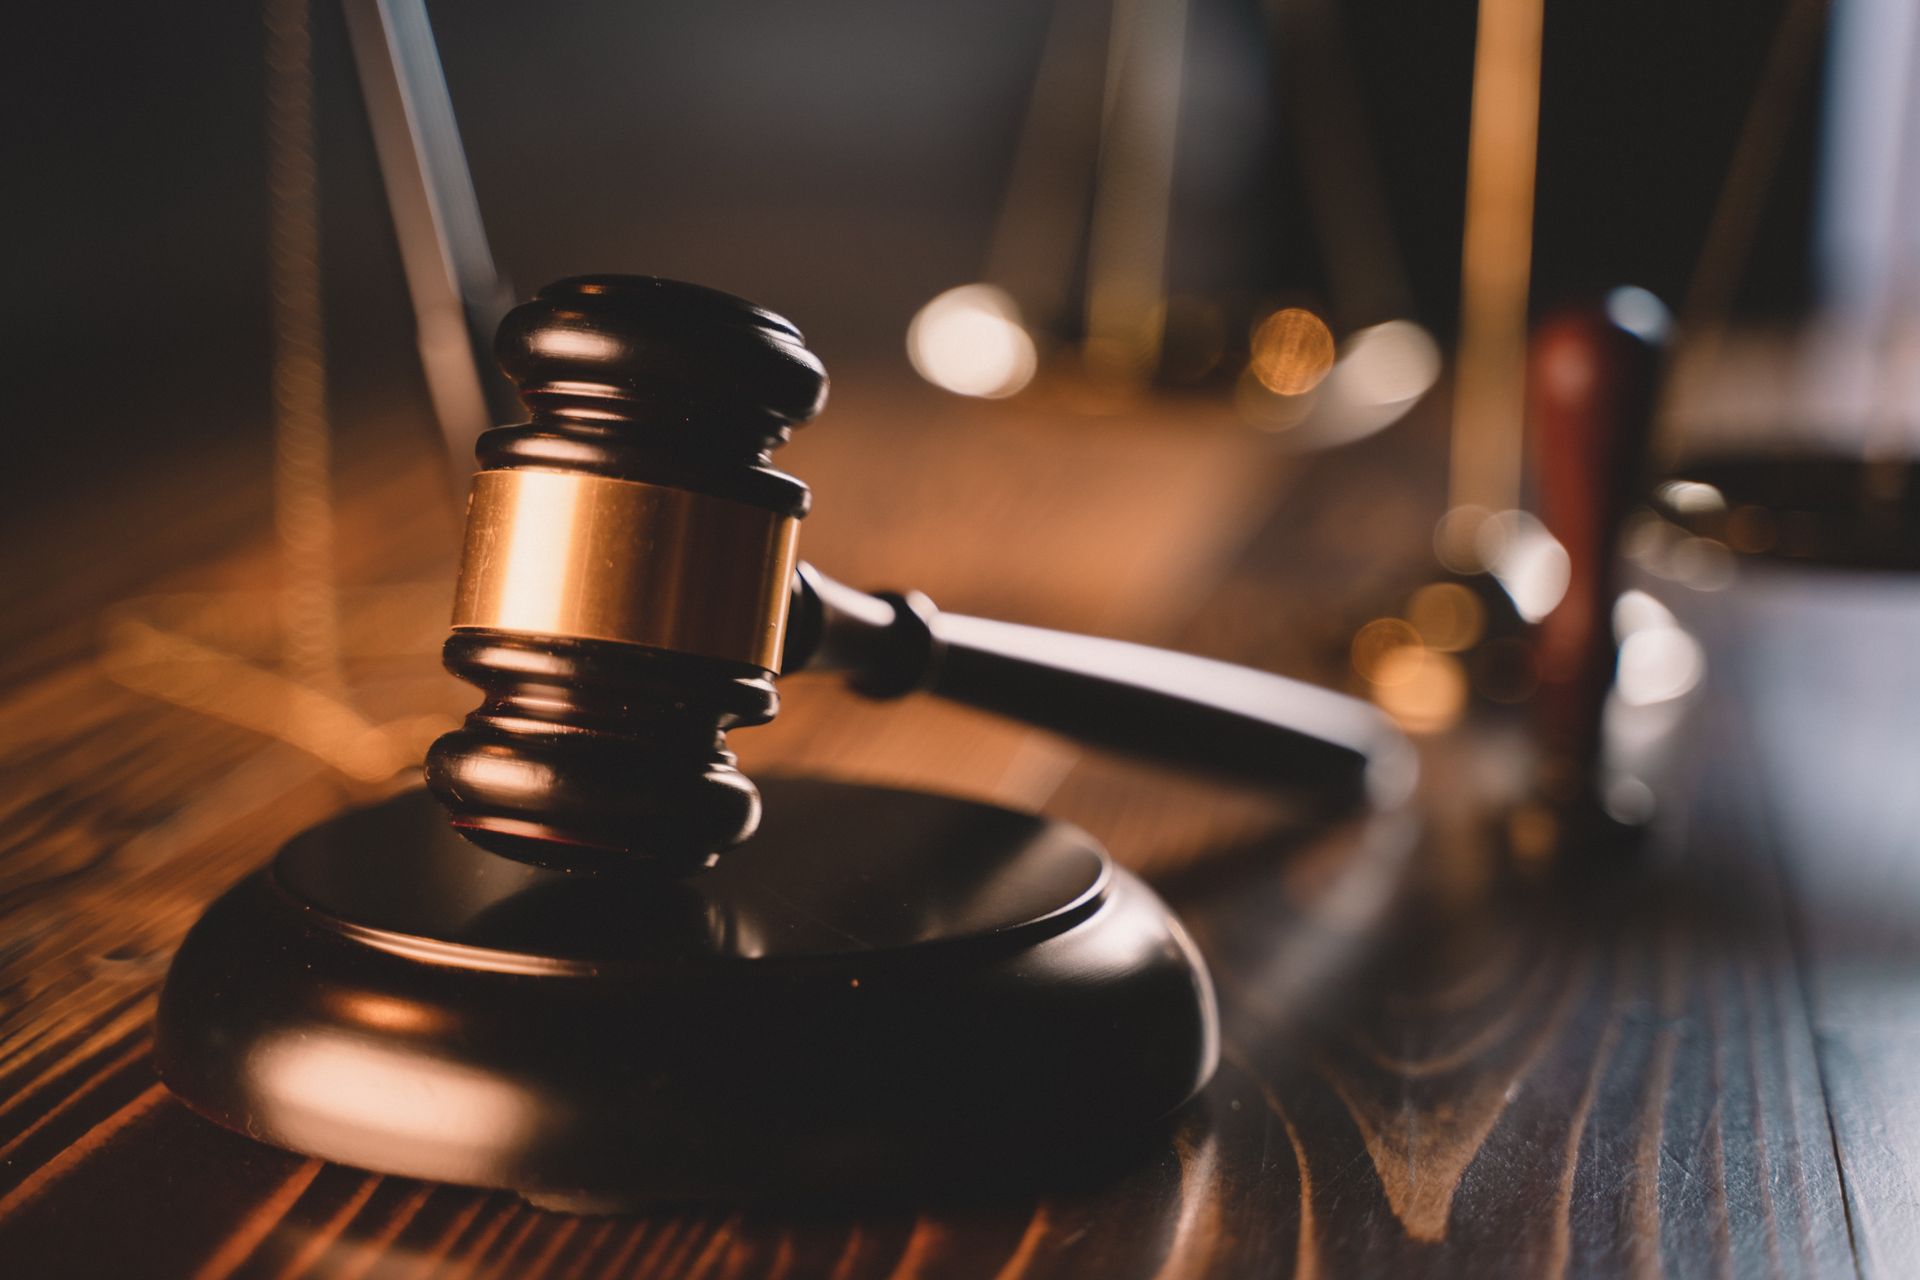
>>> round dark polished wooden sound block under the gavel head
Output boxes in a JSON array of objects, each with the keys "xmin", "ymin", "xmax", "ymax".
[{"xmin": 156, "ymin": 779, "xmax": 1219, "ymax": 1209}]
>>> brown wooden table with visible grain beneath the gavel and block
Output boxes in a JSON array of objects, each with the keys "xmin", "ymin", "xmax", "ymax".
[{"xmin": 0, "ymin": 376, "xmax": 1920, "ymax": 1278}]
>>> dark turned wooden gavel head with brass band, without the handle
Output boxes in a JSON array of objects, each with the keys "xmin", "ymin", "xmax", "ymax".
[{"xmin": 426, "ymin": 276, "xmax": 828, "ymax": 875}]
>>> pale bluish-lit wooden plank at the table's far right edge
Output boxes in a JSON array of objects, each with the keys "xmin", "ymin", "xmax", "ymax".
[{"xmin": 1693, "ymin": 568, "xmax": 1920, "ymax": 1276}]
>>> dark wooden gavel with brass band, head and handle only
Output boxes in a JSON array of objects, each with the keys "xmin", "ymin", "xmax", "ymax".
[{"xmin": 426, "ymin": 276, "xmax": 1413, "ymax": 873}]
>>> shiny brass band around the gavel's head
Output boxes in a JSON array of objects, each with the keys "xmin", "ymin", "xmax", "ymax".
[{"xmin": 453, "ymin": 470, "xmax": 801, "ymax": 672}]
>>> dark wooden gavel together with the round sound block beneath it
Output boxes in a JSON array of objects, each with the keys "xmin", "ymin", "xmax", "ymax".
[{"xmin": 156, "ymin": 276, "xmax": 1413, "ymax": 1209}]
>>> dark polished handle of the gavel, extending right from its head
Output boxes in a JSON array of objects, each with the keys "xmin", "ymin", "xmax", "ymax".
[{"xmin": 783, "ymin": 564, "xmax": 1417, "ymax": 808}]
